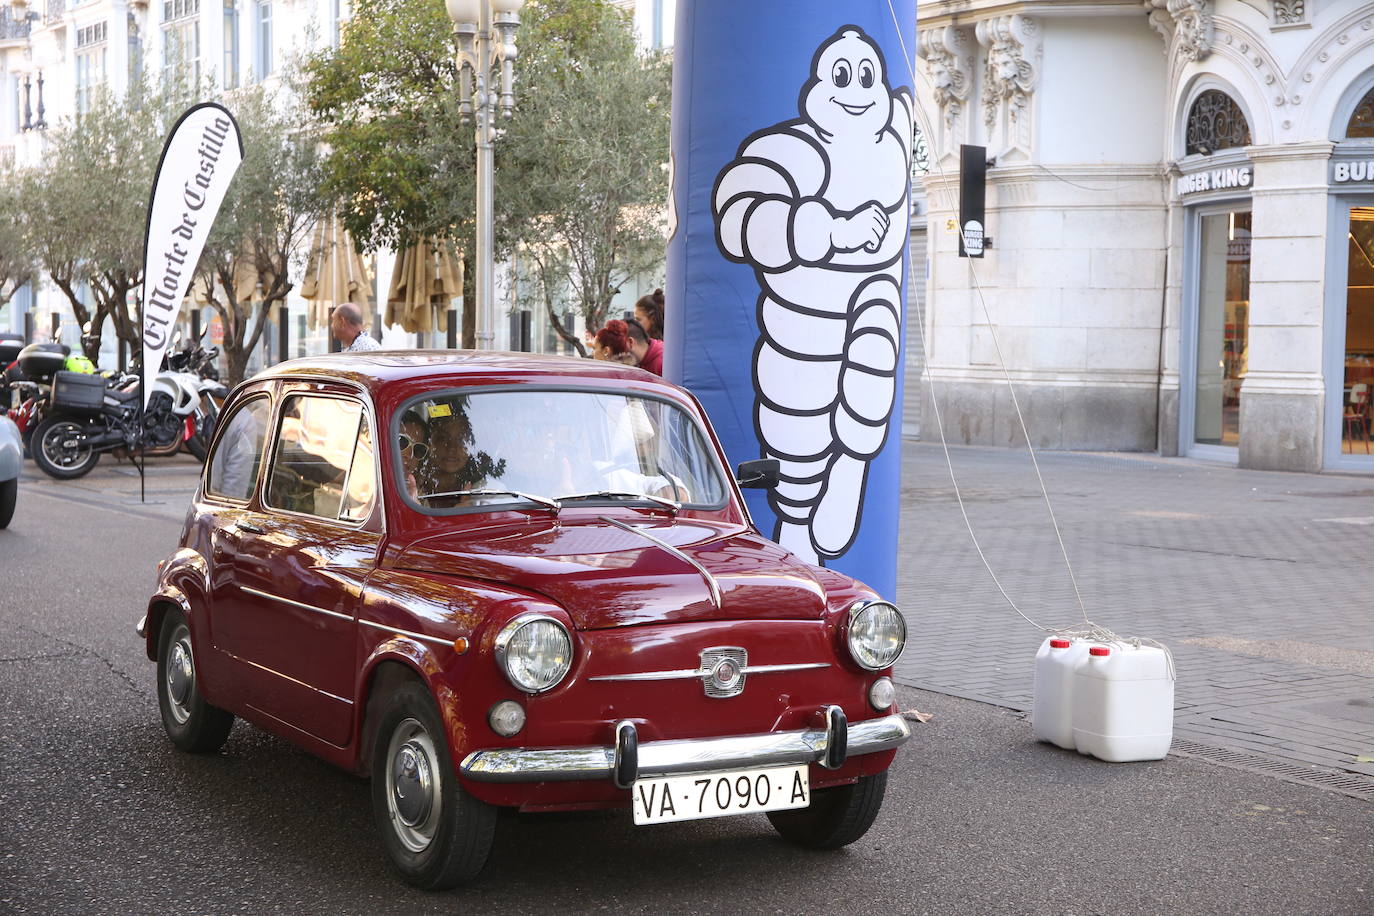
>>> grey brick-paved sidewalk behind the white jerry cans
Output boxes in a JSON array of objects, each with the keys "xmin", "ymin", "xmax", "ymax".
[{"xmin": 897, "ymin": 441, "xmax": 1374, "ymax": 791}]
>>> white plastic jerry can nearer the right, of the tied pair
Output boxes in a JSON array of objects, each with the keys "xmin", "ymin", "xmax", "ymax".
[{"xmin": 1072, "ymin": 645, "xmax": 1173, "ymax": 764}]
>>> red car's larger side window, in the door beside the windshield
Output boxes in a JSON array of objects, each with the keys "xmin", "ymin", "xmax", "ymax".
[{"xmin": 267, "ymin": 394, "xmax": 376, "ymax": 520}]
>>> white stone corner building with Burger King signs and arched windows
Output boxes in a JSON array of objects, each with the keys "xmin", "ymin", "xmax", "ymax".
[{"xmin": 911, "ymin": 0, "xmax": 1374, "ymax": 471}]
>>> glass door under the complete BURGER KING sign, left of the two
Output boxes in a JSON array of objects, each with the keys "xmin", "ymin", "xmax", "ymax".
[{"xmin": 1190, "ymin": 210, "xmax": 1250, "ymax": 453}]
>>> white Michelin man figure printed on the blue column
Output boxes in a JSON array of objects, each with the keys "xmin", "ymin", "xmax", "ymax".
[{"xmin": 712, "ymin": 26, "xmax": 912, "ymax": 562}]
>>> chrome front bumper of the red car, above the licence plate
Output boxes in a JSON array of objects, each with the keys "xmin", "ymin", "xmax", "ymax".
[{"xmin": 459, "ymin": 706, "xmax": 911, "ymax": 788}]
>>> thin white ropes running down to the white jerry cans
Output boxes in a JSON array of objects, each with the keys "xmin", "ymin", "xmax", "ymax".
[{"xmin": 888, "ymin": 0, "xmax": 1175, "ymax": 680}]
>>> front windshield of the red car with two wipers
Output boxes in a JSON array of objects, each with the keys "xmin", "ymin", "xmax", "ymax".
[{"xmin": 394, "ymin": 390, "xmax": 725, "ymax": 511}]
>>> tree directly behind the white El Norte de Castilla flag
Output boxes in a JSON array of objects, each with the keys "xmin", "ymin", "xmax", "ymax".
[{"xmin": 196, "ymin": 84, "xmax": 328, "ymax": 385}]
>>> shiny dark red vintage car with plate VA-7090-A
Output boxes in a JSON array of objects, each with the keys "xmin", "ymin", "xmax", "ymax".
[{"xmin": 137, "ymin": 352, "xmax": 910, "ymax": 889}]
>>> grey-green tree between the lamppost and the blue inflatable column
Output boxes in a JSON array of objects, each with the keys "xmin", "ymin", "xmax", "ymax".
[{"xmin": 496, "ymin": 0, "xmax": 672, "ymax": 352}]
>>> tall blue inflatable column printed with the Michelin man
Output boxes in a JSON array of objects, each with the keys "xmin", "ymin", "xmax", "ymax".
[{"xmin": 665, "ymin": 0, "xmax": 916, "ymax": 599}]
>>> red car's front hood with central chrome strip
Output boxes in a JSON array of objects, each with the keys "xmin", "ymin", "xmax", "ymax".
[{"xmin": 393, "ymin": 516, "xmax": 826, "ymax": 629}]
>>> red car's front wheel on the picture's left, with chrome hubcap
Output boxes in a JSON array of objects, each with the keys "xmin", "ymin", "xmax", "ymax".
[{"xmin": 371, "ymin": 680, "xmax": 496, "ymax": 890}]
